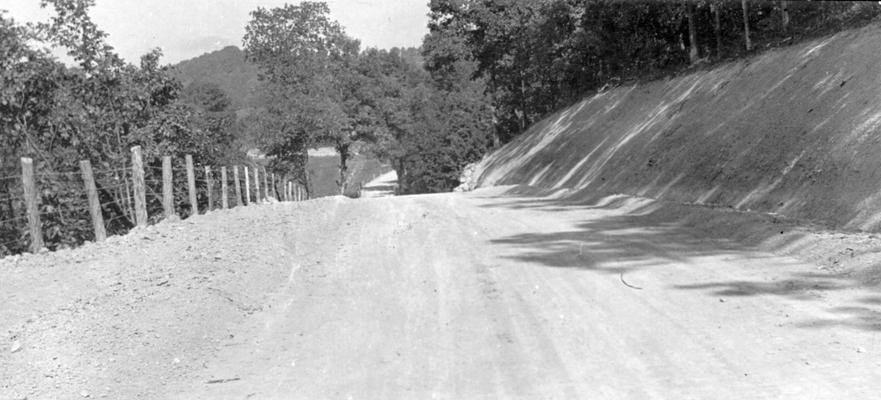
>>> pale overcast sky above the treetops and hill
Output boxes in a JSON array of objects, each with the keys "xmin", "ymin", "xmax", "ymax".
[{"xmin": 0, "ymin": 0, "xmax": 429, "ymax": 63}]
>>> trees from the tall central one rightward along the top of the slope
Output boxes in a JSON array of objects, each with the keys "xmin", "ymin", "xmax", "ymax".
[{"xmin": 237, "ymin": 0, "xmax": 881, "ymax": 193}]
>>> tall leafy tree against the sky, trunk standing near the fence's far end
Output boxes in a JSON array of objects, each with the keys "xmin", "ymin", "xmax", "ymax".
[{"xmin": 244, "ymin": 1, "xmax": 361, "ymax": 193}]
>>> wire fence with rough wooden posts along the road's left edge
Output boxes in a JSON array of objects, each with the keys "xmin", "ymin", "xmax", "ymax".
[{"xmin": 0, "ymin": 151, "xmax": 308, "ymax": 257}]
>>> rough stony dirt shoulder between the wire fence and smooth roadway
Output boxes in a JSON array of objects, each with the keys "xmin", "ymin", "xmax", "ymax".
[{"xmin": 0, "ymin": 197, "xmax": 347, "ymax": 399}]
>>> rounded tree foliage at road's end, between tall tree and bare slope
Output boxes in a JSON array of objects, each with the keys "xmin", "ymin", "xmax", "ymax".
[{"xmin": 360, "ymin": 49, "xmax": 492, "ymax": 193}]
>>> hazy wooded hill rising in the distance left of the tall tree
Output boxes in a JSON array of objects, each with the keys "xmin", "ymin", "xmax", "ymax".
[{"xmin": 174, "ymin": 46, "xmax": 257, "ymax": 110}]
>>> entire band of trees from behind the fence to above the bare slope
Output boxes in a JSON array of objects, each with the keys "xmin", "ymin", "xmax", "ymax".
[{"xmin": 0, "ymin": 0, "xmax": 881, "ymax": 255}]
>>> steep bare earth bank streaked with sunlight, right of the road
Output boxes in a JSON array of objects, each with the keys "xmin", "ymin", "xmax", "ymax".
[{"xmin": 477, "ymin": 23, "xmax": 881, "ymax": 231}]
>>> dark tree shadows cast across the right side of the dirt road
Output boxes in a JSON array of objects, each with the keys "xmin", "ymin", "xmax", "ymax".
[{"xmin": 484, "ymin": 189, "xmax": 881, "ymax": 331}]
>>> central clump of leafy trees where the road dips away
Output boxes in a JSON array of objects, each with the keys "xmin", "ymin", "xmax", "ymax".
[{"xmin": 245, "ymin": 2, "xmax": 492, "ymax": 193}]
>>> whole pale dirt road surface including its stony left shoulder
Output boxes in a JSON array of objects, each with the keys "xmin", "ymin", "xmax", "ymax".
[{"xmin": 0, "ymin": 188, "xmax": 881, "ymax": 399}]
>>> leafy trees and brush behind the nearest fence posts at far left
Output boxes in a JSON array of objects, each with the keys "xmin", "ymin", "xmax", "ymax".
[{"xmin": 0, "ymin": 0, "xmax": 246, "ymax": 253}]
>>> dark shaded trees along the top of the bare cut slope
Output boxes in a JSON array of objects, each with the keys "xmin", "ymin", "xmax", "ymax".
[{"xmin": 423, "ymin": 0, "xmax": 881, "ymax": 146}]
